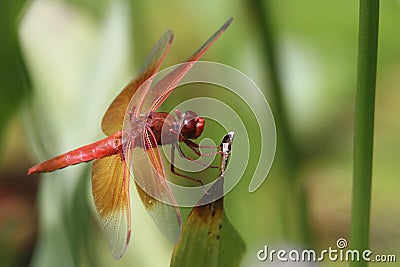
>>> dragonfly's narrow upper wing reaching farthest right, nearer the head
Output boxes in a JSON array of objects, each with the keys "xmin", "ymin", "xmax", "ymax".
[{"xmin": 142, "ymin": 18, "xmax": 232, "ymax": 111}]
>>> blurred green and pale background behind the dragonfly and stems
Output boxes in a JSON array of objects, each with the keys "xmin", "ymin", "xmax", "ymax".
[{"xmin": 0, "ymin": 0, "xmax": 400, "ymax": 266}]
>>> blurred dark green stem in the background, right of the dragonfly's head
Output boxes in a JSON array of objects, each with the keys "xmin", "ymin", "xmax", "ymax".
[{"xmin": 250, "ymin": 0, "xmax": 312, "ymax": 245}]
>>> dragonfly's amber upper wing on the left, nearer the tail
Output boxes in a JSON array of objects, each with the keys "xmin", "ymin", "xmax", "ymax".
[{"xmin": 101, "ymin": 31, "xmax": 174, "ymax": 135}]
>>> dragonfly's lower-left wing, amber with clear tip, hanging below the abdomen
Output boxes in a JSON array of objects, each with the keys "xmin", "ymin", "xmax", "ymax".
[{"xmin": 92, "ymin": 155, "xmax": 131, "ymax": 259}]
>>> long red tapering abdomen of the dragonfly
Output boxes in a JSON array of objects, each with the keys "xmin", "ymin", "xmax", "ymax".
[{"xmin": 28, "ymin": 131, "xmax": 122, "ymax": 175}]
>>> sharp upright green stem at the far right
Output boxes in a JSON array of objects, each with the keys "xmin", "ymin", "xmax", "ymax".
[{"xmin": 350, "ymin": 0, "xmax": 379, "ymax": 267}]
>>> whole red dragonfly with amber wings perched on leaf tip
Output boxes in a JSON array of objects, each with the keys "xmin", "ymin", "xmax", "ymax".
[{"xmin": 28, "ymin": 19, "xmax": 232, "ymax": 259}]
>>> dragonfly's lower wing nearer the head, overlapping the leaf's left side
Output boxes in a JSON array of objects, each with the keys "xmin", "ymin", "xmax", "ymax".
[{"xmin": 124, "ymin": 128, "xmax": 181, "ymax": 243}]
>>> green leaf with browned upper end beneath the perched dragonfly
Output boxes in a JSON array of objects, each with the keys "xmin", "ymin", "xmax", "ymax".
[{"xmin": 171, "ymin": 177, "xmax": 246, "ymax": 267}]
